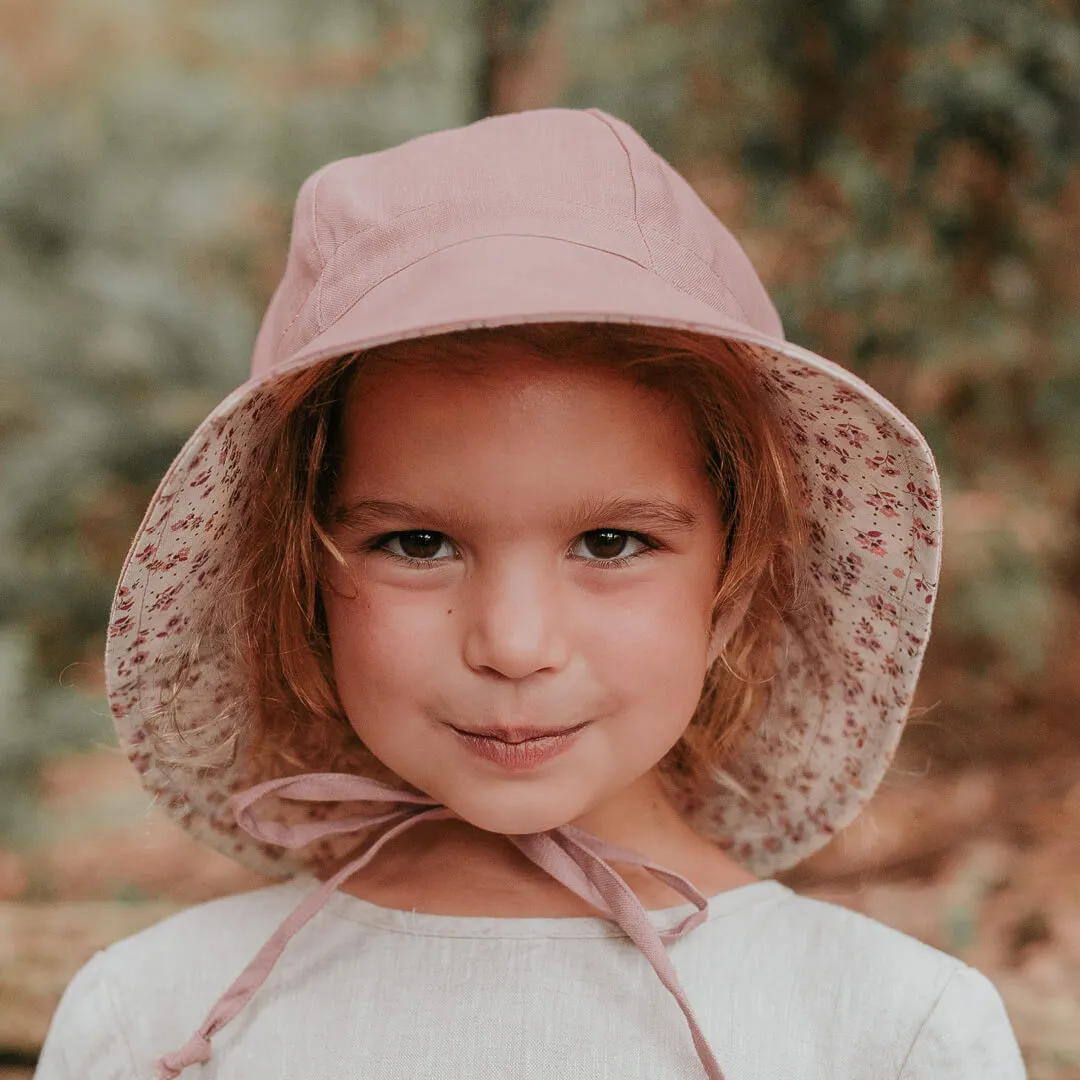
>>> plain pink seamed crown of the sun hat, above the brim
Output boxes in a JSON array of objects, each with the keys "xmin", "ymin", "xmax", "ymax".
[{"xmin": 252, "ymin": 108, "xmax": 783, "ymax": 375}]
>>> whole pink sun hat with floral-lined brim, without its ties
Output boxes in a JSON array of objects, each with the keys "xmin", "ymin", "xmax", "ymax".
[{"xmin": 106, "ymin": 108, "xmax": 941, "ymax": 877}]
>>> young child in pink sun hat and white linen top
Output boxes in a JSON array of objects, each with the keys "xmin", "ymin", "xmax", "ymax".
[{"xmin": 37, "ymin": 109, "xmax": 1024, "ymax": 1080}]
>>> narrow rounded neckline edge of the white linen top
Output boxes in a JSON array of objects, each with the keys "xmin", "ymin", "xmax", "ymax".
[{"xmin": 288, "ymin": 874, "xmax": 794, "ymax": 939}]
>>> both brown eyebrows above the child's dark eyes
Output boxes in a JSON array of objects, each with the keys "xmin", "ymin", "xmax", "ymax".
[{"xmin": 330, "ymin": 498, "xmax": 699, "ymax": 532}]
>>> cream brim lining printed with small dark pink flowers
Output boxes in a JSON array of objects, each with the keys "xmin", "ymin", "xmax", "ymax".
[{"xmin": 106, "ymin": 318, "xmax": 941, "ymax": 876}]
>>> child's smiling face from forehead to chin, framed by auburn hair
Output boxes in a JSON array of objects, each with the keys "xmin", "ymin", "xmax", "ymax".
[{"xmin": 323, "ymin": 349, "xmax": 724, "ymax": 833}]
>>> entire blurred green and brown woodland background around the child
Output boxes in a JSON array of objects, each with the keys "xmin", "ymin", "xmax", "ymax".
[{"xmin": 0, "ymin": 0, "xmax": 1080, "ymax": 1080}]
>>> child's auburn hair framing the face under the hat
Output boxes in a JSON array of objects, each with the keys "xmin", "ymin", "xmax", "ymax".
[{"xmin": 152, "ymin": 323, "xmax": 808, "ymax": 814}]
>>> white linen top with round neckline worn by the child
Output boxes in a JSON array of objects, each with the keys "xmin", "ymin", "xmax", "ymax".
[{"xmin": 35, "ymin": 875, "xmax": 1026, "ymax": 1080}]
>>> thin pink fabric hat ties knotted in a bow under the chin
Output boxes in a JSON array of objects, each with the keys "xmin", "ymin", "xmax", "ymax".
[{"xmin": 157, "ymin": 772, "xmax": 724, "ymax": 1080}]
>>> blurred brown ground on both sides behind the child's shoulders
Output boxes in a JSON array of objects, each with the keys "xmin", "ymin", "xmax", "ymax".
[{"xmin": 6, "ymin": 745, "xmax": 1080, "ymax": 1080}]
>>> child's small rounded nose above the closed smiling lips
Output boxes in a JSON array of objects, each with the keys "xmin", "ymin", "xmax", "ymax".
[{"xmin": 462, "ymin": 561, "xmax": 570, "ymax": 679}]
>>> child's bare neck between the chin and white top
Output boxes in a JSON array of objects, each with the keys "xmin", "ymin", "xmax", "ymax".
[{"xmin": 332, "ymin": 773, "xmax": 758, "ymax": 918}]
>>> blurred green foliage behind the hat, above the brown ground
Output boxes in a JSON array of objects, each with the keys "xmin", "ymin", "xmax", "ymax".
[{"xmin": 0, "ymin": 0, "xmax": 1080, "ymax": 835}]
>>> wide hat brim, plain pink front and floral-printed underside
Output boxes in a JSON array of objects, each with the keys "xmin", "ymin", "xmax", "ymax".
[{"xmin": 106, "ymin": 234, "xmax": 941, "ymax": 876}]
